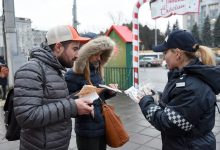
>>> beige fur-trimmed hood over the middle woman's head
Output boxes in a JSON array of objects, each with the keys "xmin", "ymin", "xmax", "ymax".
[{"xmin": 73, "ymin": 36, "xmax": 115, "ymax": 74}]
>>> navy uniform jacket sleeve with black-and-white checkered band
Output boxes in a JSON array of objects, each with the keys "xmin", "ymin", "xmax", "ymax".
[{"xmin": 139, "ymin": 84, "xmax": 207, "ymax": 135}]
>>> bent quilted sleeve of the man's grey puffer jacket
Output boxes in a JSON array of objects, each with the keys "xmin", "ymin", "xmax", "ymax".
[{"xmin": 14, "ymin": 63, "xmax": 77, "ymax": 128}]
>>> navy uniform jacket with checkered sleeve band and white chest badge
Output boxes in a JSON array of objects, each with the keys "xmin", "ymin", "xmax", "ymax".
[{"xmin": 139, "ymin": 59, "xmax": 220, "ymax": 150}]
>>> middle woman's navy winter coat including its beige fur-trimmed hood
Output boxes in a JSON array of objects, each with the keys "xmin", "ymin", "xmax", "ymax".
[{"xmin": 65, "ymin": 36, "xmax": 115, "ymax": 137}]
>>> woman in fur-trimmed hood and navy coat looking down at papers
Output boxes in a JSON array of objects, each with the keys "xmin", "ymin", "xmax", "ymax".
[{"xmin": 65, "ymin": 36, "xmax": 117, "ymax": 150}]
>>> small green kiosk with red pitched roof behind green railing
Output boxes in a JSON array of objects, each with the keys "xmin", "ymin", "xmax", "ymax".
[{"xmin": 105, "ymin": 25, "xmax": 133, "ymax": 89}]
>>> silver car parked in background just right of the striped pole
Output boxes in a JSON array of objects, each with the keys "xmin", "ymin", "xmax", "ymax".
[{"xmin": 139, "ymin": 57, "xmax": 162, "ymax": 67}]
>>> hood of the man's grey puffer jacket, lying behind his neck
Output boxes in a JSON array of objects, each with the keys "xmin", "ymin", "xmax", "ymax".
[{"xmin": 30, "ymin": 42, "xmax": 65, "ymax": 70}]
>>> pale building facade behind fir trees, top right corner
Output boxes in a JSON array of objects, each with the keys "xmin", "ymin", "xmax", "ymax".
[{"xmin": 183, "ymin": 0, "xmax": 220, "ymax": 31}]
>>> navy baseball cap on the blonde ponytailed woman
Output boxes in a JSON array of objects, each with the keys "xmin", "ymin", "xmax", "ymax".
[{"xmin": 153, "ymin": 30, "xmax": 196, "ymax": 52}]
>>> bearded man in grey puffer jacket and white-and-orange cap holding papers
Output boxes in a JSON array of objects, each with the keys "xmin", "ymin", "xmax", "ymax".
[{"xmin": 14, "ymin": 25, "xmax": 93, "ymax": 150}]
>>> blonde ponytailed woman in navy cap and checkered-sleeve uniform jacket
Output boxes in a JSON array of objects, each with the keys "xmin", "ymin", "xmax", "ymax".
[{"xmin": 138, "ymin": 30, "xmax": 220, "ymax": 150}]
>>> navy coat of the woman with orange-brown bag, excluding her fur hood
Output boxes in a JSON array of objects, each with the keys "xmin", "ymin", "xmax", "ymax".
[{"xmin": 65, "ymin": 66, "xmax": 115, "ymax": 137}]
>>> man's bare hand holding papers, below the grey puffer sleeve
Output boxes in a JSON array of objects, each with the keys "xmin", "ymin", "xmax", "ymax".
[{"xmin": 75, "ymin": 98, "xmax": 93, "ymax": 115}]
